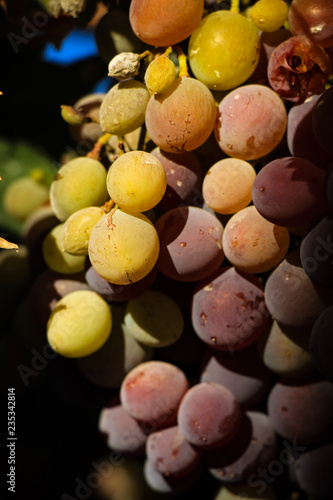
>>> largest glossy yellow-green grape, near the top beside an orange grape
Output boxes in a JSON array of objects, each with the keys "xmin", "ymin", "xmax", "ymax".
[{"xmin": 188, "ymin": 10, "xmax": 260, "ymax": 90}]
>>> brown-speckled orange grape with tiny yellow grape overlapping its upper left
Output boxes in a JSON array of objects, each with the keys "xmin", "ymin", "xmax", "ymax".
[{"xmin": 146, "ymin": 77, "xmax": 216, "ymax": 153}]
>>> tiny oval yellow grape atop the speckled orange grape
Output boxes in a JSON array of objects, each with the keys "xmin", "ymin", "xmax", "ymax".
[{"xmin": 145, "ymin": 54, "xmax": 177, "ymax": 94}]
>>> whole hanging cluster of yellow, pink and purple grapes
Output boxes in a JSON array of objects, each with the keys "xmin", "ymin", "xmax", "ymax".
[{"xmin": 0, "ymin": 0, "xmax": 333, "ymax": 500}]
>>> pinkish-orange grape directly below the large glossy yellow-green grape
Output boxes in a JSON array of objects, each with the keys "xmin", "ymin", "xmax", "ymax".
[{"xmin": 215, "ymin": 85, "xmax": 287, "ymax": 160}]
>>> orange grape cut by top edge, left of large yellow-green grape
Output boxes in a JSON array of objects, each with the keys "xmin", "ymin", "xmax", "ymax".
[{"xmin": 129, "ymin": 0, "xmax": 204, "ymax": 47}]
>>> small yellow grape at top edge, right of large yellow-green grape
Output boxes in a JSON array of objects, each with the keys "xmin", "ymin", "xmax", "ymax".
[{"xmin": 250, "ymin": 0, "xmax": 288, "ymax": 31}]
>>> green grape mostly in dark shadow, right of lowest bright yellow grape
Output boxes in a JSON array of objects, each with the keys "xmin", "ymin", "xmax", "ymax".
[{"xmin": 124, "ymin": 290, "xmax": 184, "ymax": 347}]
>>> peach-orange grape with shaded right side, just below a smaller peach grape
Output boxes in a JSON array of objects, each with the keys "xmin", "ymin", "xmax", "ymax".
[{"xmin": 222, "ymin": 206, "xmax": 289, "ymax": 273}]
